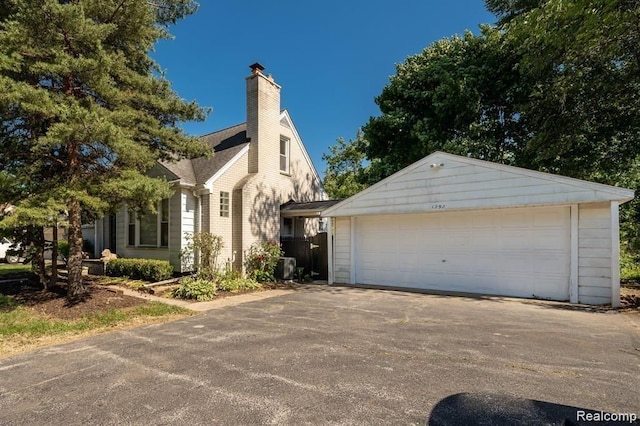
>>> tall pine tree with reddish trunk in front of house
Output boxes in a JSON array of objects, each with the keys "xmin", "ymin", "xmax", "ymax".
[{"xmin": 0, "ymin": 0, "xmax": 207, "ymax": 296}]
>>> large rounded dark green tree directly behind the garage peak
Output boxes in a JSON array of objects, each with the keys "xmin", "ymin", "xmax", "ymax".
[{"xmin": 363, "ymin": 26, "xmax": 528, "ymax": 183}]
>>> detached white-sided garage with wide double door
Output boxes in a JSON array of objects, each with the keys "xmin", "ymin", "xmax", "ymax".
[{"xmin": 323, "ymin": 152, "xmax": 633, "ymax": 306}]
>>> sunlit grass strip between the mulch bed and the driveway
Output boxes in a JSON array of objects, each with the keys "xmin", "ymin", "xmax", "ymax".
[{"xmin": 0, "ymin": 295, "xmax": 194, "ymax": 358}]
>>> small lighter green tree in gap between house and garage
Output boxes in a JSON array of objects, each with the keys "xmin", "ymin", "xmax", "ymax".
[{"xmin": 322, "ymin": 132, "xmax": 367, "ymax": 199}]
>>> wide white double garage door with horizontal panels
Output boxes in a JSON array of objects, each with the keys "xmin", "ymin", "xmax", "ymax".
[{"xmin": 355, "ymin": 207, "xmax": 571, "ymax": 300}]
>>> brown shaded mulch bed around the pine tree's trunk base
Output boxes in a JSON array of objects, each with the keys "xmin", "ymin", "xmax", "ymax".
[{"xmin": 0, "ymin": 274, "xmax": 147, "ymax": 320}]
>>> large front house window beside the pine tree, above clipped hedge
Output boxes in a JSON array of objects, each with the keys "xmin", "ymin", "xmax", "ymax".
[{"xmin": 127, "ymin": 199, "xmax": 169, "ymax": 247}]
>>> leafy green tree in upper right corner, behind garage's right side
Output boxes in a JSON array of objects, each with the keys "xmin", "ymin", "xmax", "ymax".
[{"xmin": 503, "ymin": 0, "xmax": 640, "ymax": 180}]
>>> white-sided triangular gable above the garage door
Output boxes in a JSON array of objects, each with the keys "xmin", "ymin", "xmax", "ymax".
[{"xmin": 323, "ymin": 151, "xmax": 634, "ymax": 217}]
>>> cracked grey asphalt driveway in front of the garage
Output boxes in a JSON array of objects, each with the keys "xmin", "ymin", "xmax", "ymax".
[{"xmin": 0, "ymin": 286, "xmax": 640, "ymax": 425}]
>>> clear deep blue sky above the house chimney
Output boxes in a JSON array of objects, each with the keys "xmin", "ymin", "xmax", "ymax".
[{"xmin": 153, "ymin": 0, "xmax": 494, "ymax": 175}]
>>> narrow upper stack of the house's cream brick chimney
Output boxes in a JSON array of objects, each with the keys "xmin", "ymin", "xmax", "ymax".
[{"xmin": 246, "ymin": 62, "xmax": 280, "ymax": 173}]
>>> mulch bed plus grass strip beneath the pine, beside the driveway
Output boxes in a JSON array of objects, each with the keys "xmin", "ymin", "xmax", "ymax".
[{"xmin": 0, "ymin": 272, "xmax": 194, "ymax": 358}]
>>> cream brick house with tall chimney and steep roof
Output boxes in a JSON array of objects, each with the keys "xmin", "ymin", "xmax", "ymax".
[{"xmin": 83, "ymin": 63, "xmax": 327, "ymax": 271}]
